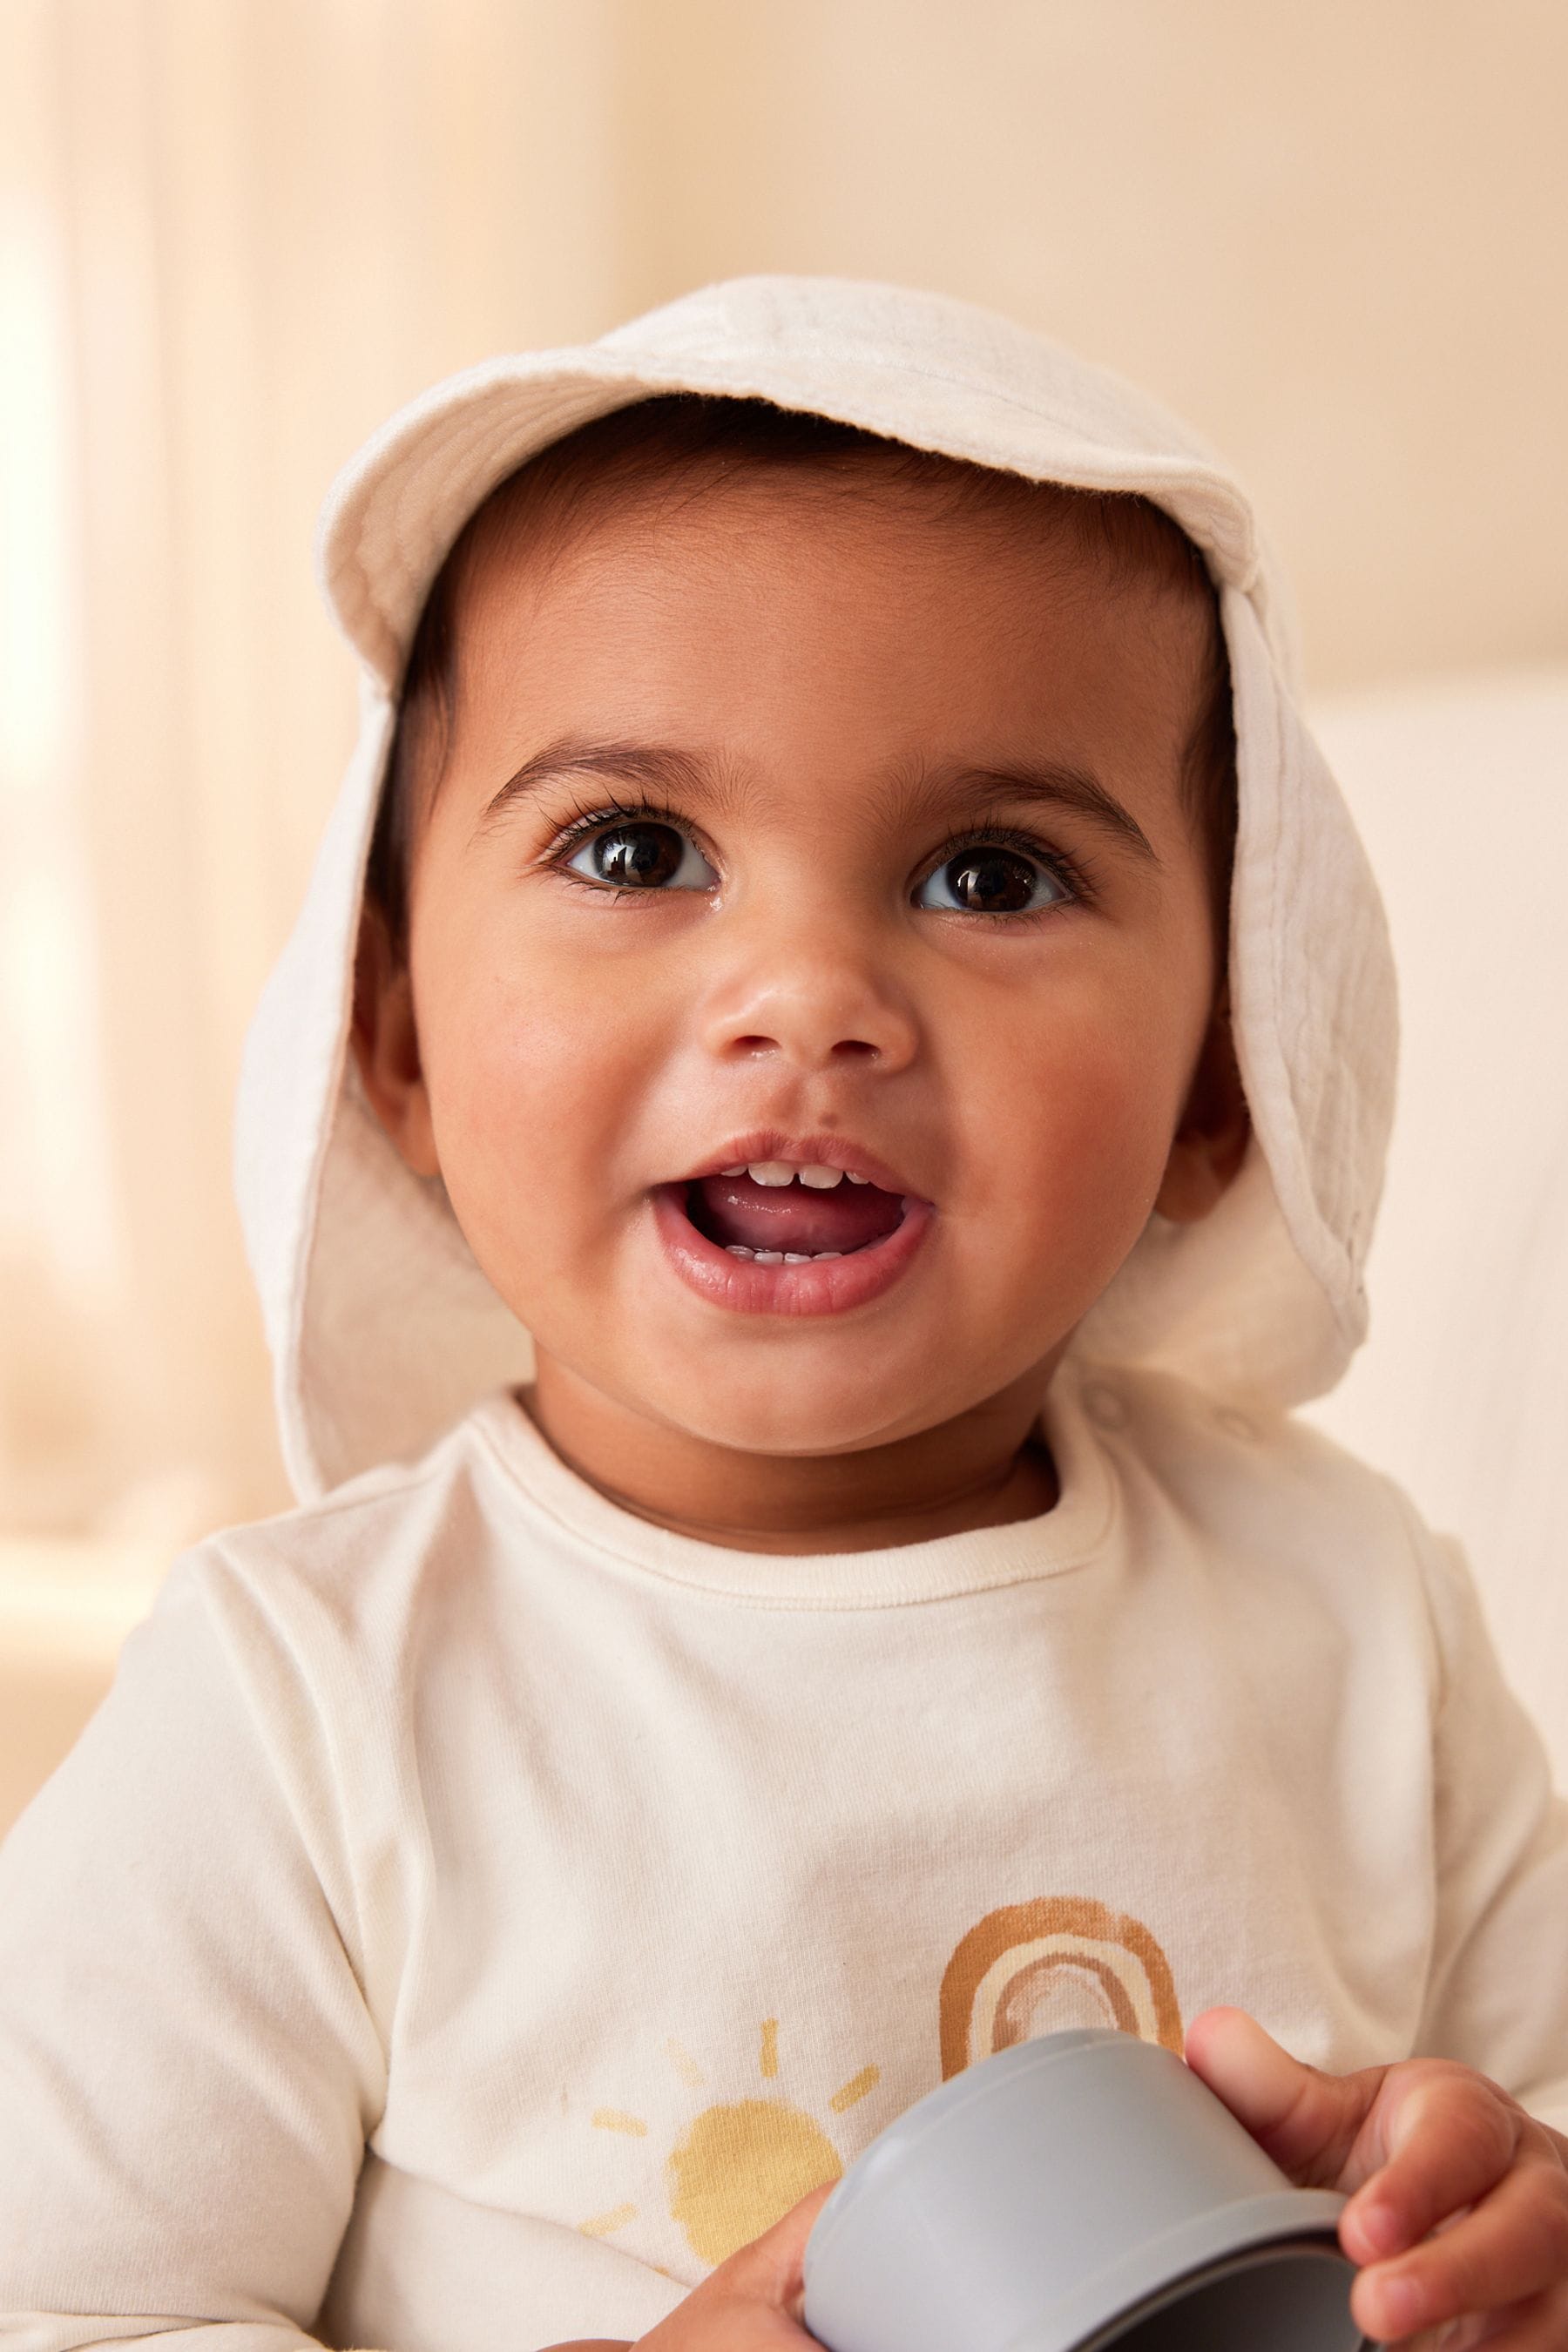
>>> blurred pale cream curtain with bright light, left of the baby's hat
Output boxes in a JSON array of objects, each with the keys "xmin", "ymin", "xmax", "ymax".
[{"xmin": 0, "ymin": 0, "xmax": 620, "ymax": 1543}]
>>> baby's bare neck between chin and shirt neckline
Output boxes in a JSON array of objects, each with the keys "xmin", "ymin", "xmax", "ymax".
[{"xmin": 517, "ymin": 1353, "xmax": 1058, "ymax": 1552}]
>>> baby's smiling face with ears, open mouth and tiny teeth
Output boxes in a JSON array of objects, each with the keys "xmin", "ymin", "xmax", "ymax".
[{"xmin": 367, "ymin": 473, "xmax": 1222, "ymax": 1454}]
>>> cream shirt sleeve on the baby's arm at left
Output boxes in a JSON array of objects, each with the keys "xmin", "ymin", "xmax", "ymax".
[{"xmin": 0, "ymin": 1552, "xmax": 386, "ymax": 2352}]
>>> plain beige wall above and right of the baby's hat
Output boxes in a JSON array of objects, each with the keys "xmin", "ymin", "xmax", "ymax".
[{"xmin": 623, "ymin": 0, "xmax": 1568, "ymax": 686}]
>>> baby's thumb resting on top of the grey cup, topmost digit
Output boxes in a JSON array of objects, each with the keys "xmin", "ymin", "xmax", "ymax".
[{"xmin": 1187, "ymin": 2009, "xmax": 1387, "ymax": 2190}]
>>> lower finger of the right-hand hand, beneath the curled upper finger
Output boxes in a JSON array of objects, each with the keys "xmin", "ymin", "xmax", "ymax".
[{"xmin": 1349, "ymin": 2143, "xmax": 1568, "ymax": 2352}]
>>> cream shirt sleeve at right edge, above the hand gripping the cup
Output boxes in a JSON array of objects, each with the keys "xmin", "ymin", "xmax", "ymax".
[{"xmin": 1417, "ymin": 1536, "xmax": 1568, "ymax": 2131}]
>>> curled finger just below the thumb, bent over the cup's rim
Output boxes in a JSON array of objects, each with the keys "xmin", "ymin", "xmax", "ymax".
[{"xmin": 1340, "ymin": 2063, "xmax": 1535, "ymax": 2262}]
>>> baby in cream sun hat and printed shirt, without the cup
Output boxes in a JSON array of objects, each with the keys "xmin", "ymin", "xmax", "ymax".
[{"xmin": 0, "ymin": 280, "xmax": 1568, "ymax": 2352}]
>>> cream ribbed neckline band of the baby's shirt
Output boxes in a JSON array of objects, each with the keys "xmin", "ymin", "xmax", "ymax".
[{"xmin": 470, "ymin": 1367, "xmax": 1117, "ymax": 1609}]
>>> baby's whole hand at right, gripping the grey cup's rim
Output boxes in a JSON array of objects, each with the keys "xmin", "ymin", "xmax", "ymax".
[{"xmin": 1187, "ymin": 2009, "xmax": 1568, "ymax": 2352}]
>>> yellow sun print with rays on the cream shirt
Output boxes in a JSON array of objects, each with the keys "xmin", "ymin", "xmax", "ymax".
[{"xmin": 578, "ymin": 2018, "xmax": 882, "ymax": 2262}]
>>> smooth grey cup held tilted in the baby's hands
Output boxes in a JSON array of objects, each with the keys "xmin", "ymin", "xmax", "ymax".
[{"xmin": 804, "ymin": 2030, "xmax": 1363, "ymax": 2352}]
